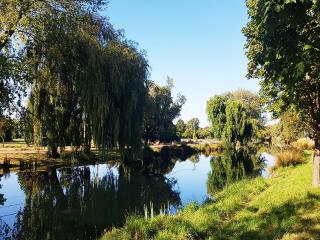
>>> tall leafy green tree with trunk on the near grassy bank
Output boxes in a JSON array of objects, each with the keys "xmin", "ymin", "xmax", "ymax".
[{"xmin": 243, "ymin": 0, "xmax": 320, "ymax": 186}]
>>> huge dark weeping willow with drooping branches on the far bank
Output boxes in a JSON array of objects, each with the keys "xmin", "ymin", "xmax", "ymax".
[{"xmin": 26, "ymin": 14, "xmax": 148, "ymax": 157}]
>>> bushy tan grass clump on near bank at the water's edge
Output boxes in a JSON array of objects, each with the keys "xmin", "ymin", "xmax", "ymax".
[{"xmin": 275, "ymin": 148, "xmax": 305, "ymax": 168}]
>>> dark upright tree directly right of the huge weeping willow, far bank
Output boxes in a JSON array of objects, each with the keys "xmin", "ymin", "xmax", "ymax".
[{"xmin": 144, "ymin": 78, "xmax": 186, "ymax": 142}]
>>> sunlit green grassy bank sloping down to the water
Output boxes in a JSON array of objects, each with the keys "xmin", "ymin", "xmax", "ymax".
[{"xmin": 102, "ymin": 152, "xmax": 320, "ymax": 240}]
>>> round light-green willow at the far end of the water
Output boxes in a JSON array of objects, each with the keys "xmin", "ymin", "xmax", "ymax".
[{"xmin": 207, "ymin": 89, "xmax": 264, "ymax": 143}]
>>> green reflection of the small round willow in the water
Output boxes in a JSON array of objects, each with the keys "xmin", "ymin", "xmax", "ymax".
[{"xmin": 207, "ymin": 144, "xmax": 264, "ymax": 196}]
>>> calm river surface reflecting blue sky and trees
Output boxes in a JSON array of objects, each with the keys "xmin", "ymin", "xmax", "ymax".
[{"xmin": 0, "ymin": 151, "xmax": 272, "ymax": 240}]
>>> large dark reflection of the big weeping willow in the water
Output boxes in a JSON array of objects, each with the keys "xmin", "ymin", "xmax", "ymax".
[{"xmin": 0, "ymin": 165, "xmax": 181, "ymax": 240}]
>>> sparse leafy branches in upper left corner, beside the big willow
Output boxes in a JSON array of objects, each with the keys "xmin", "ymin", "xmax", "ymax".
[{"xmin": 0, "ymin": 0, "xmax": 106, "ymax": 116}]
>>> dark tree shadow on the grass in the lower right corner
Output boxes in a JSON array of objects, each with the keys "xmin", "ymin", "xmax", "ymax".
[{"xmin": 211, "ymin": 192, "xmax": 320, "ymax": 239}]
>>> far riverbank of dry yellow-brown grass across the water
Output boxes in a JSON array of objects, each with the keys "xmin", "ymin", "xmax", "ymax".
[{"xmin": 0, "ymin": 139, "xmax": 222, "ymax": 168}]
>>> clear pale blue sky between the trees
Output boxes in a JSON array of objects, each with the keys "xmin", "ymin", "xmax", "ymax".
[{"xmin": 103, "ymin": 0, "xmax": 259, "ymax": 127}]
